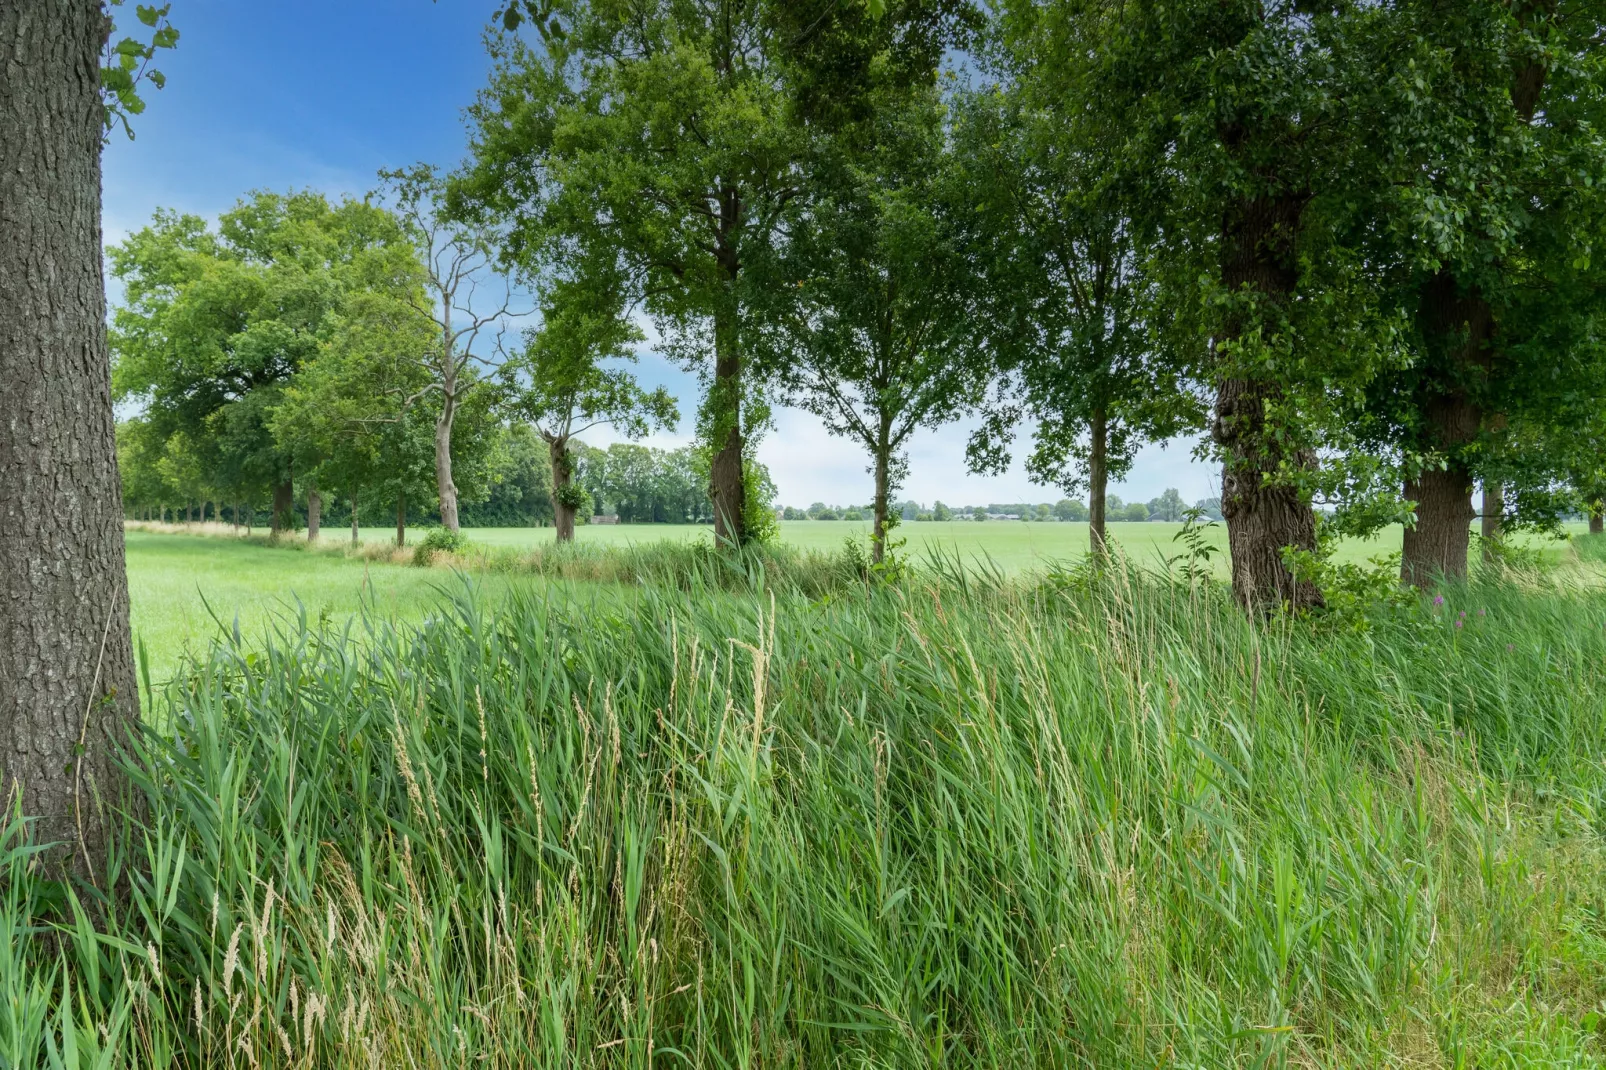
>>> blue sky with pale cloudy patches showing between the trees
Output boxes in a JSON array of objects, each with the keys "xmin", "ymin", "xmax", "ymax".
[{"xmin": 104, "ymin": 0, "xmax": 1217, "ymax": 506}]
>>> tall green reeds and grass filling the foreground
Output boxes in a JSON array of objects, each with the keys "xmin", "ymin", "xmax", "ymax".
[{"xmin": 0, "ymin": 552, "xmax": 1606, "ymax": 1068}]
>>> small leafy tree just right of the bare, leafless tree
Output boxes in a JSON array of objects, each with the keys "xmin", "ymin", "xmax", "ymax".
[{"xmin": 503, "ymin": 284, "xmax": 679, "ymax": 543}]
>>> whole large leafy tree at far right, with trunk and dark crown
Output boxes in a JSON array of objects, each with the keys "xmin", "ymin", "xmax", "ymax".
[{"xmin": 1373, "ymin": 0, "xmax": 1606, "ymax": 586}]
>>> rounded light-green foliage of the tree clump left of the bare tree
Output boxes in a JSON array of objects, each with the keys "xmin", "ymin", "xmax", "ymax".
[{"xmin": 108, "ymin": 193, "xmax": 418, "ymax": 514}]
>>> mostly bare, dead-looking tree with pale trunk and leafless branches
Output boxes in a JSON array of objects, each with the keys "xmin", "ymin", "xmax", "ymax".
[{"xmin": 369, "ymin": 164, "xmax": 520, "ymax": 532}]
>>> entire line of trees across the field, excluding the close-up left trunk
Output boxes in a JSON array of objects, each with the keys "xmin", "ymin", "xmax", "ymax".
[{"xmin": 112, "ymin": 0, "xmax": 1606, "ymax": 607}]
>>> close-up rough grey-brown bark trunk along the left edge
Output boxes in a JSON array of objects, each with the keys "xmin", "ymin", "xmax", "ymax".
[{"xmin": 0, "ymin": 0, "xmax": 138, "ymax": 877}]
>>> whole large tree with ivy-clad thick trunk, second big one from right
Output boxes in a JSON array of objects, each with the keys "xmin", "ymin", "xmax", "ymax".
[{"xmin": 1040, "ymin": 0, "xmax": 1397, "ymax": 612}]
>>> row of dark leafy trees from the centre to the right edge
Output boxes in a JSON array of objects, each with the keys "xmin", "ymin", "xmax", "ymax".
[{"xmin": 436, "ymin": 0, "xmax": 1606, "ymax": 609}]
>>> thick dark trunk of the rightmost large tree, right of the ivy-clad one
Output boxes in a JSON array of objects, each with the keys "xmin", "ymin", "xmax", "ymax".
[{"xmin": 1400, "ymin": 272, "xmax": 1494, "ymax": 586}]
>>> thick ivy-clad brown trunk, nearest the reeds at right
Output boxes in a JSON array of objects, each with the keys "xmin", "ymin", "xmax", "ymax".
[{"xmin": 1211, "ymin": 196, "xmax": 1322, "ymax": 611}]
